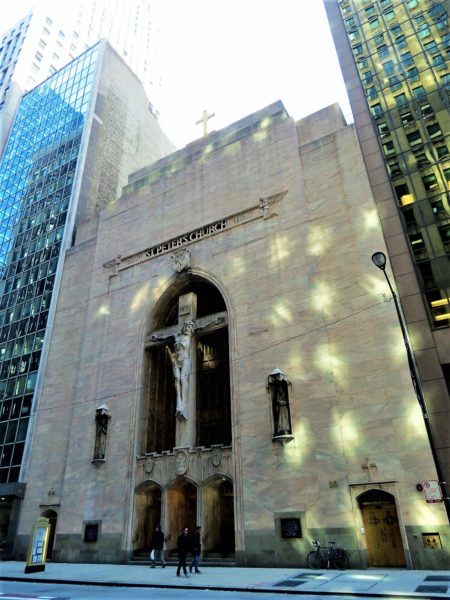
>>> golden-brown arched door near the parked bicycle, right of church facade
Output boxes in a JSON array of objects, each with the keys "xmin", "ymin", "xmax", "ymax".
[{"xmin": 357, "ymin": 489, "xmax": 406, "ymax": 567}]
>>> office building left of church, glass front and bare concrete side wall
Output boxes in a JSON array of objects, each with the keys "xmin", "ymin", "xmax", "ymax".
[{"xmin": 0, "ymin": 41, "xmax": 174, "ymax": 554}]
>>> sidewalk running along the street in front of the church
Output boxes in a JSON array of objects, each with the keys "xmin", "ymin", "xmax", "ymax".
[{"xmin": 0, "ymin": 561, "xmax": 450, "ymax": 600}]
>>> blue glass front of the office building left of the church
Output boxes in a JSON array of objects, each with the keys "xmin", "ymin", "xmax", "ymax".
[{"xmin": 0, "ymin": 45, "xmax": 99, "ymax": 484}]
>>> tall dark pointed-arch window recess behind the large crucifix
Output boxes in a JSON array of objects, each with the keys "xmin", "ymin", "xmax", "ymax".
[{"xmin": 139, "ymin": 272, "xmax": 232, "ymax": 454}]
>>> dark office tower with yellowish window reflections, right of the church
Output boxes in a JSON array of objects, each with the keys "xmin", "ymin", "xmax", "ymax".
[{"xmin": 325, "ymin": 0, "xmax": 450, "ymax": 496}]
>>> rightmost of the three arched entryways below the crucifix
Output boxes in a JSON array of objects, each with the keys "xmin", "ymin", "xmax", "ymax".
[{"xmin": 202, "ymin": 476, "xmax": 234, "ymax": 556}]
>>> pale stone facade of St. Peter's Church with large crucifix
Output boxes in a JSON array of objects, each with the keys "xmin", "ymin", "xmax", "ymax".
[{"xmin": 15, "ymin": 102, "xmax": 449, "ymax": 568}]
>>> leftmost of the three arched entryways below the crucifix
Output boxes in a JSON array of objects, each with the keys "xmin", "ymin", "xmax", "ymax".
[{"xmin": 133, "ymin": 481, "xmax": 161, "ymax": 553}]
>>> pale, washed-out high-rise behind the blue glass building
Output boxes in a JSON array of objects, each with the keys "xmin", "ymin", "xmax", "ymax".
[{"xmin": 0, "ymin": 0, "xmax": 161, "ymax": 154}]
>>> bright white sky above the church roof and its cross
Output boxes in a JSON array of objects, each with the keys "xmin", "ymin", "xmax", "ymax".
[{"xmin": 0, "ymin": 0, "xmax": 352, "ymax": 147}]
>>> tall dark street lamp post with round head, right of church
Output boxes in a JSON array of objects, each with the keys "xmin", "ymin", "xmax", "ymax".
[{"xmin": 372, "ymin": 252, "xmax": 450, "ymax": 522}]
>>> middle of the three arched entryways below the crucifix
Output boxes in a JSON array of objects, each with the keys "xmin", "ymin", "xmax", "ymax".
[{"xmin": 166, "ymin": 478, "xmax": 197, "ymax": 551}]
